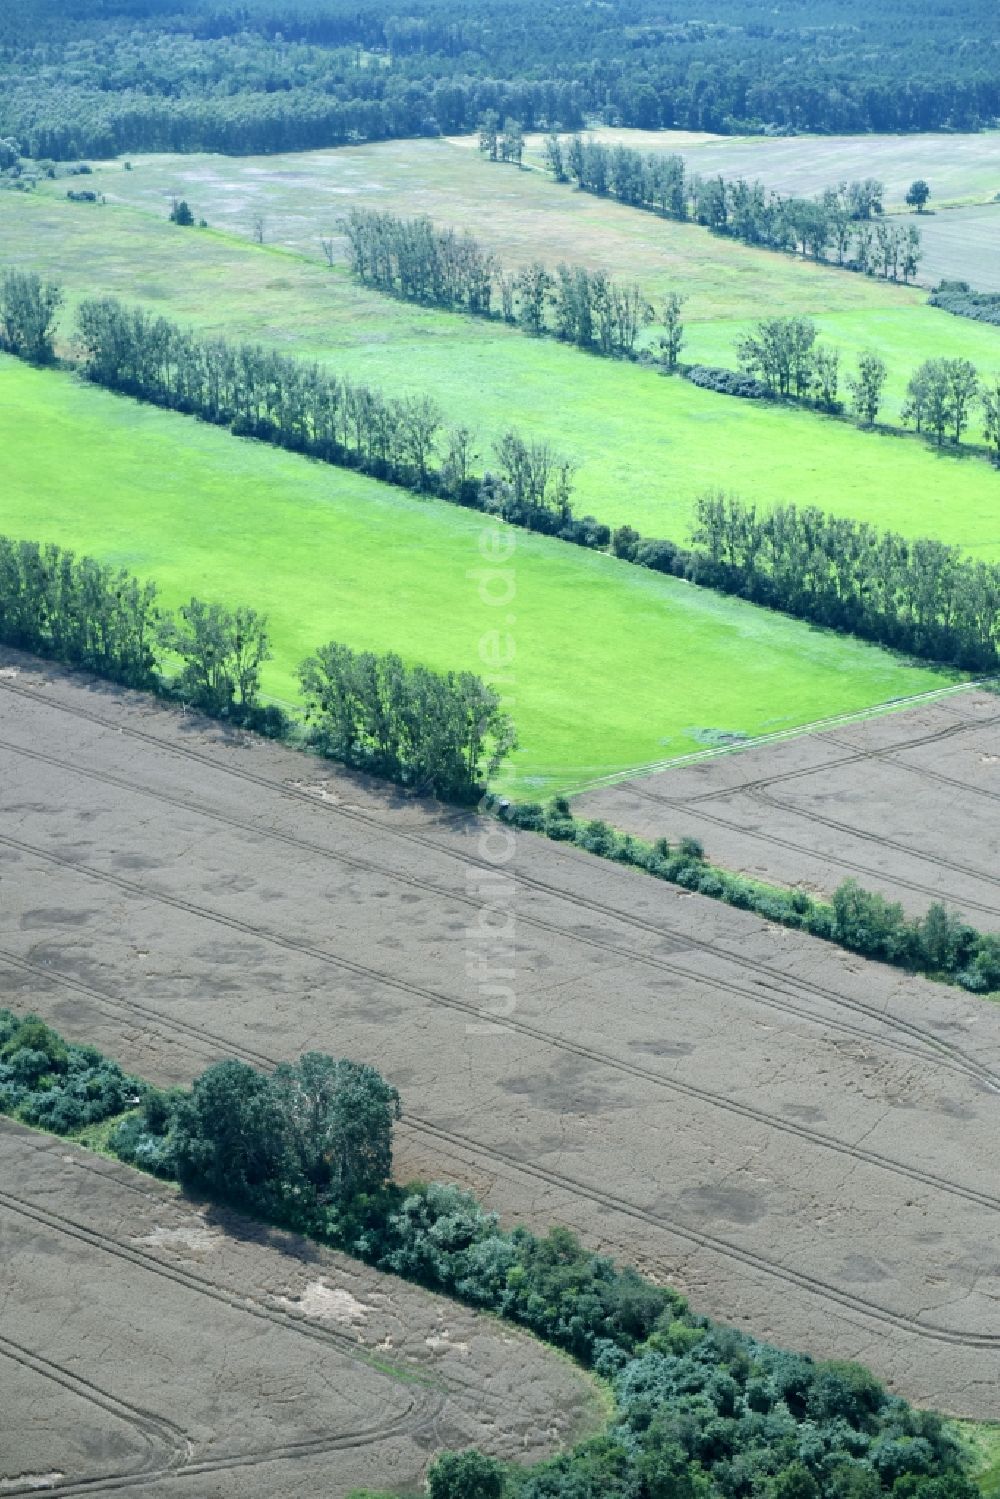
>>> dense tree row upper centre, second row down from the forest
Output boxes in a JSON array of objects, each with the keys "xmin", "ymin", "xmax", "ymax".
[{"xmin": 340, "ymin": 208, "xmax": 654, "ymax": 358}]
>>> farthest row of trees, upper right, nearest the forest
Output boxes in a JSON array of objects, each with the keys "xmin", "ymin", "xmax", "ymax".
[{"xmin": 546, "ymin": 133, "xmax": 922, "ymax": 282}]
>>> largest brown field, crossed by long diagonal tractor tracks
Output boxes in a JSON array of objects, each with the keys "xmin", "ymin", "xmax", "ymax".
[{"xmin": 0, "ymin": 655, "xmax": 1000, "ymax": 1418}]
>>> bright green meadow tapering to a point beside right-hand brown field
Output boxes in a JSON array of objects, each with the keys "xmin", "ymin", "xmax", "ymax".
[{"xmin": 0, "ymin": 358, "xmax": 948, "ymax": 794}]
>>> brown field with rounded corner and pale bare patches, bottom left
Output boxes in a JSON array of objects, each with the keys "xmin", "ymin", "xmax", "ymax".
[{"xmin": 0, "ymin": 1121, "xmax": 598, "ymax": 1499}]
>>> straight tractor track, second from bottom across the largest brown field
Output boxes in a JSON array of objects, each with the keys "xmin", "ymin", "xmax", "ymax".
[{"xmin": 0, "ymin": 833, "xmax": 1000, "ymax": 1211}]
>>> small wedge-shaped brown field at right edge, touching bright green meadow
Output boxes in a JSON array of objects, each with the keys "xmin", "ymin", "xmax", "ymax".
[{"xmin": 573, "ymin": 690, "xmax": 1000, "ymax": 931}]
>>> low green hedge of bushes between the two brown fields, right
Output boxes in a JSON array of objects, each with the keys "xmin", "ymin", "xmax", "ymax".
[{"xmin": 496, "ymin": 796, "xmax": 1000, "ymax": 994}]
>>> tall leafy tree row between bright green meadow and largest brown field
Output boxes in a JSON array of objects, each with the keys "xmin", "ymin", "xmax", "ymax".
[{"xmin": 0, "ymin": 535, "xmax": 517, "ymax": 802}]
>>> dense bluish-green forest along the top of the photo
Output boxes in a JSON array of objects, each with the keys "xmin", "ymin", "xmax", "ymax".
[{"xmin": 0, "ymin": 0, "xmax": 1000, "ymax": 160}]
